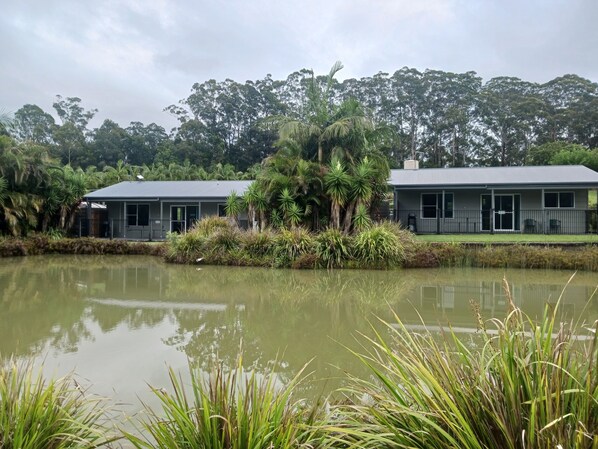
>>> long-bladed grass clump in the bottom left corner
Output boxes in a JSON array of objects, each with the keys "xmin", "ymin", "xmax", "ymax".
[{"xmin": 0, "ymin": 359, "xmax": 115, "ymax": 449}]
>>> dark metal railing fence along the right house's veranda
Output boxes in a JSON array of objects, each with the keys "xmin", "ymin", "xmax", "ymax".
[{"xmin": 393, "ymin": 209, "xmax": 598, "ymax": 234}]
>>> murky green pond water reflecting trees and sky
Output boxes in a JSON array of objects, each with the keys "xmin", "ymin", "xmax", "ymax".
[{"xmin": 0, "ymin": 256, "xmax": 598, "ymax": 409}]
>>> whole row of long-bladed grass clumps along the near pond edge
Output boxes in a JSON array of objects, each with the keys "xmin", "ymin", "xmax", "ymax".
[{"xmin": 0, "ymin": 300, "xmax": 598, "ymax": 449}]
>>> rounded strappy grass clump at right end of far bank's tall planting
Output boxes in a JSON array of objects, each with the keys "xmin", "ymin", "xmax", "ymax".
[{"xmin": 354, "ymin": 225, "xmax": 405, "ymax": 268}]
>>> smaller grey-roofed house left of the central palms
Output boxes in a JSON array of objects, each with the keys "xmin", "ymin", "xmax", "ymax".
[{"xmin": 79, "ymin": 180, "xmax": 252, "ymax": 240}]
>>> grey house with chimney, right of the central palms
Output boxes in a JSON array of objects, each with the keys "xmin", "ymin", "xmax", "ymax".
[{"xmin": 389, "ymin": 161, "xmax": 598, "ymax": 234}]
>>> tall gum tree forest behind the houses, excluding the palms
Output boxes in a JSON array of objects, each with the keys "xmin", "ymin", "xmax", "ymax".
[{"xmin": 3, "ymin": 68, "xmax": 598, "ymax": 171}]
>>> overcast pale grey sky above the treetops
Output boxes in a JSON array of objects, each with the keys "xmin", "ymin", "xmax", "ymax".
[{"xmin": 0, "ymin": 0, "xmax": 598, "ymax": 129}]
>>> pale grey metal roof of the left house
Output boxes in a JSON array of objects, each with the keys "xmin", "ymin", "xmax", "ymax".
[{"xmin": 85, "ymin": 181, "xmax": 253, "ymax": 201}]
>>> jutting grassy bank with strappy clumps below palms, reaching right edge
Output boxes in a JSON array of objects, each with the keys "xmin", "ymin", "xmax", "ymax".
[{"xmin": 166, "ymin": 219, "xmax": 598, "ymax": 271}]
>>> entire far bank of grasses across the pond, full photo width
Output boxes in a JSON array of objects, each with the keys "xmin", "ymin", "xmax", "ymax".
[{"xmin": 0, "ymin": 218, "xmax": 598, "ymax": 271}]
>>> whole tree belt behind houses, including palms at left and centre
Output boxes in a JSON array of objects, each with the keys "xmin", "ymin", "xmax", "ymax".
[{"xmin": 0, "ymin": 63, "xmax": 598, "ymax": 235}]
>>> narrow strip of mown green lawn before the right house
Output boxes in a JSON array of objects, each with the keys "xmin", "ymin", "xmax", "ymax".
[{"xmin": 417, "ymin": 233, "xmax": 598, "ymax": 243}]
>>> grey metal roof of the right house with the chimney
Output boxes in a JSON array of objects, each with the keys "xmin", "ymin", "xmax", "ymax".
[{"xmin": 389, "ymin": 165, "xmax": 598, "ymax": 189}]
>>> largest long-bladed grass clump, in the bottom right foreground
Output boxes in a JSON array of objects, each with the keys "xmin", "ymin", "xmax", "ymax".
[{"xmin": 328, "ymin": 278, "xmax": 598, "ymax": 449}]
